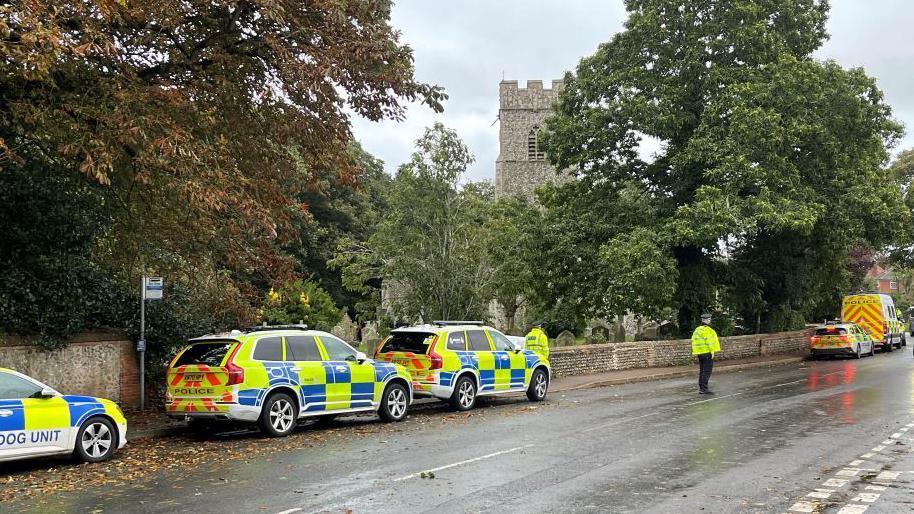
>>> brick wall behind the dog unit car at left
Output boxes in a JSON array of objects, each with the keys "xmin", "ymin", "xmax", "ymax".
[{"xmin": 0, "ymin": 332, "xmax": 140, "ymax": 407}]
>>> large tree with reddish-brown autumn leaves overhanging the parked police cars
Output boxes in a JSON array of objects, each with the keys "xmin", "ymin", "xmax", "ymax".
[{"xmin": 0, "ymin": 0, "xmax": 445, "ymax": 343}]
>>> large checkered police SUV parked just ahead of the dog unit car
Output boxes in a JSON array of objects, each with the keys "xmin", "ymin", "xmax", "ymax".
[{"xmin": 165, "ymin": 325, "xmax": 413, "ymax": 437}]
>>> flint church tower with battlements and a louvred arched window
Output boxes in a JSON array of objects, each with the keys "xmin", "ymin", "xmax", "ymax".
[{"xmin": 495, "ymin": 80, "xmax": 568, "ymax": 199}]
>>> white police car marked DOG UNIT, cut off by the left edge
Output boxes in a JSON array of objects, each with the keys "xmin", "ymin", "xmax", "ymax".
[{"xmin": 0, "ymin": 368, "xmax": 127, "ymax": 462}]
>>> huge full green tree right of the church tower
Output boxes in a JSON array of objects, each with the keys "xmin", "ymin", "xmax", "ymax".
[{"xmin": 547, "ymin": 0, "xmax": 910, "ymax": 331}]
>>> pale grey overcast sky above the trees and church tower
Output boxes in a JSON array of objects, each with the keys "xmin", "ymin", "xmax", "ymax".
[{"xmin": 353, "ymin": 0, "xmax": 914, "ymax": 180}]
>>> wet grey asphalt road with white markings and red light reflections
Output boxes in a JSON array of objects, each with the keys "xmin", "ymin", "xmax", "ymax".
[{"xmin": 8, "ymin": 346, "xmax": 914, "ymax": 513}]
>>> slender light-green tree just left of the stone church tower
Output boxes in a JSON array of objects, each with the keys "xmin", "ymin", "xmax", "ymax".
[{"xmin": 333, "ymin": 123, "xmax": 493, "ymax": 321}]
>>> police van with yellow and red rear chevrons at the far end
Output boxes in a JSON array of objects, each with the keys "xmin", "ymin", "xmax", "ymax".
[{"xmin": 841, "ymin": 293, "xmax": 907, "ymax": 352}]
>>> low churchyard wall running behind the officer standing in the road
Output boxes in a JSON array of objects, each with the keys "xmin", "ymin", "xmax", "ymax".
[{"xmin": 549, "ymin": 331, "xmax": 808, "ymax": 376}]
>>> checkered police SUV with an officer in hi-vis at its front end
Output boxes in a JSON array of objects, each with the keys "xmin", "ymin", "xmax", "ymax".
[{"xmin": 376, "ymin": 321, "xmax": 551, "ymax": 410}]
